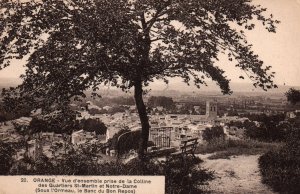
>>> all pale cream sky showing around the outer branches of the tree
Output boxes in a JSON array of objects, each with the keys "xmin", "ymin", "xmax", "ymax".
[{"xmin": 0, "ymin": 0, "xmax": 300, "ymax": 86}]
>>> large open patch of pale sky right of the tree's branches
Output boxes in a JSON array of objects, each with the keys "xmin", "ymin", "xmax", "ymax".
[{"xmin": 241, "ymin": 0, "xmax": 300, "ymax": 86}]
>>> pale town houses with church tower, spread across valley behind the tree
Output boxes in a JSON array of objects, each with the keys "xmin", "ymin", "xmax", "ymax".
[{"xmin": 0, "ymin": 101, "xmax": 262, "ymax": 159}]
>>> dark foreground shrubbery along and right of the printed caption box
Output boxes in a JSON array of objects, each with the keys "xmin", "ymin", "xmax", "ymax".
[{"xmin": 10, "ymin": 149, "xmax": 214, "ymax": 194}]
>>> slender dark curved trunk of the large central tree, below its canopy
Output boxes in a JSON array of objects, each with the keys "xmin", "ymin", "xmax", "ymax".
[{"xmin": 134, "ymin": 82, "xmax": 150, "ymax": 160}]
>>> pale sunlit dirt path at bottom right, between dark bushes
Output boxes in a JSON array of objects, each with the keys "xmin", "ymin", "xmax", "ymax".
[{"xmin": 199, "ymin": 155, "xmax": 274, "ymax": 194}]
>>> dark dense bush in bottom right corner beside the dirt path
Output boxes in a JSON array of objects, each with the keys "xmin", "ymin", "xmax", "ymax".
[{"xmin": 259, "ymin": 129, "xmax": 300, "ymax": 194}]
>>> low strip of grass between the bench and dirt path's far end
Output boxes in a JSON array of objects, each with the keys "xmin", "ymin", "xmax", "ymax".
[{"xmin": 195, "ymin": 138, "xmax": 283, "ymax": 159}]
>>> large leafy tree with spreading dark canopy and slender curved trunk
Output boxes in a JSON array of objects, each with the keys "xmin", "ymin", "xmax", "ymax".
[{"xmin": 0, "ymin": 0, "xmax": 279, "ymax": 158}]
